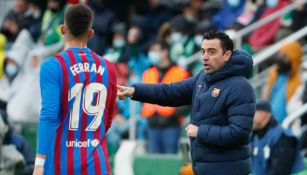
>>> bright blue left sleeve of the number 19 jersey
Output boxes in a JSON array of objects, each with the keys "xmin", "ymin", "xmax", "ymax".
[{"xmin": 37, "ymin": 58, "xmax": 62, "ymax": 156}]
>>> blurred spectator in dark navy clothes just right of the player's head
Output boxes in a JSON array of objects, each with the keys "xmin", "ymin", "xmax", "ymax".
[{"xmin": 88, "ymin": 0, "xmax": 117, "ymax": 54}]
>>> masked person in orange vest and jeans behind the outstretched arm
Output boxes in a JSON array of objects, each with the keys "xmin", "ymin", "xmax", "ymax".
[{"xmin": 141, "ymin": 42, "xmax": 190, "ymax": 154}]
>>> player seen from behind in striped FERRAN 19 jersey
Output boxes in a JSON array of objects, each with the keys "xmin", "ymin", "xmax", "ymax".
[{"xmin": 33, "ymin": 4, "xmax": 117, "ymax": 175}]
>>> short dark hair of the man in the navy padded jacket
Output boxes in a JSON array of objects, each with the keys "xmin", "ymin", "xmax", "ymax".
[{"xmin": 204, "ymin": 29, "xmax": 233, "ymax": 52}]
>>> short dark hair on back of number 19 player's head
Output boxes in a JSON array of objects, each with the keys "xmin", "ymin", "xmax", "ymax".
[{"xmin": 65, "ymin": 4, "xmax": 94, "ymax": 37}]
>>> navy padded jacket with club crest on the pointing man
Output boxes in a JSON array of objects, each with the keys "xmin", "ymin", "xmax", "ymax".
[{"xmin": 132, "ymin": 51, "xmax": 255, "ymax": 175}]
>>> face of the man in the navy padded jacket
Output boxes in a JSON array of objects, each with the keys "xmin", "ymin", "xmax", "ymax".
[{"xmin": 201, "ymin": 39, "xmax": 232, "ymax": 74}]
